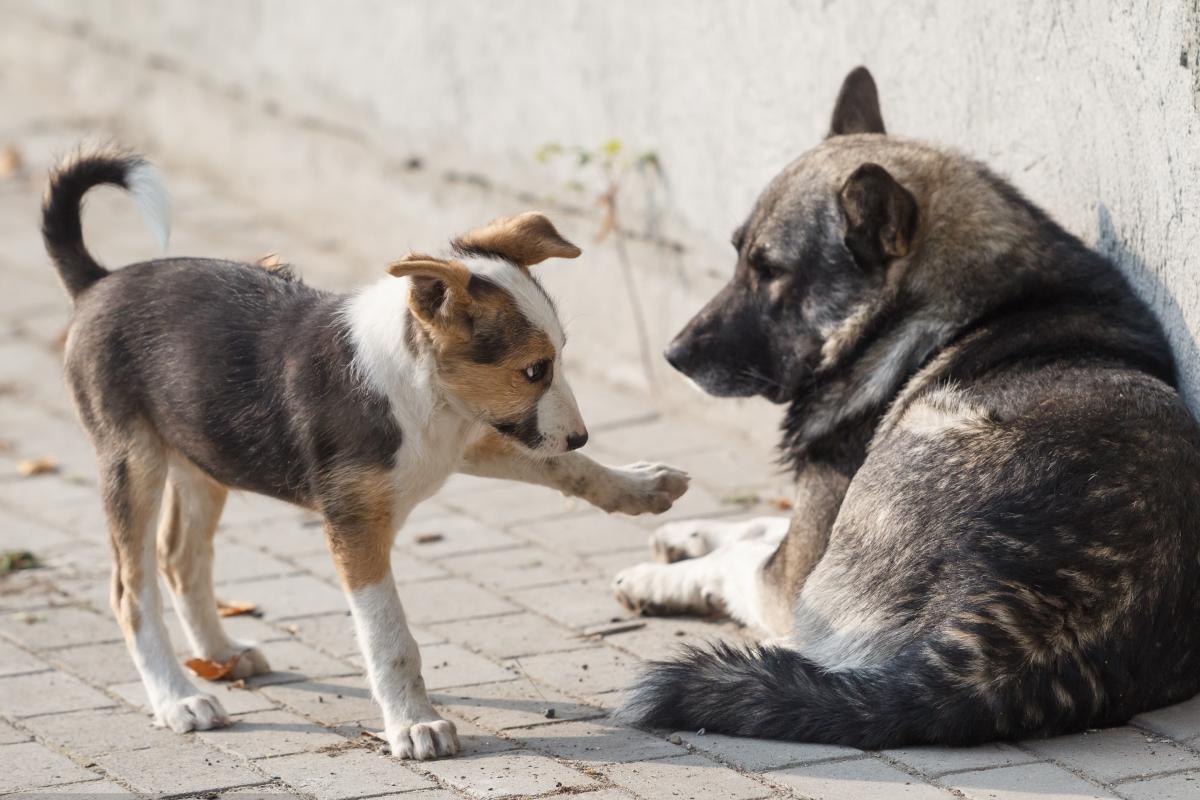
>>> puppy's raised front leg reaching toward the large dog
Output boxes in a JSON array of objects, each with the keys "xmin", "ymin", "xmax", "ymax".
[{"xmin": 460, "ymin": 433, "xmax": 689, "ymax": 515}]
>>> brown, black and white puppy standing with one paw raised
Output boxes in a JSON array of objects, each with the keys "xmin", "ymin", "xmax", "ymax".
[{"xmin": 42, "ymin": 152, "xmax": 688, "ymax": 759}]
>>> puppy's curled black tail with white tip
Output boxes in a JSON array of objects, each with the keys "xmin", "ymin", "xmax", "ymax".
[{"xmin": 42, "ymin": 149, "xmax": 170, "ymax": 299}]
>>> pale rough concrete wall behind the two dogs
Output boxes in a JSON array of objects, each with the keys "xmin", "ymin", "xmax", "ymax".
[{"xmin": 0, "ymin": 0, "xmax": 1200, "ymax": 438}]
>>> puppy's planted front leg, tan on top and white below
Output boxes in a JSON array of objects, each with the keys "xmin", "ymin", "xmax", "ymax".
[{"xmin": 325, "ymin": 503, "xmax": 458, "ymax": 760}]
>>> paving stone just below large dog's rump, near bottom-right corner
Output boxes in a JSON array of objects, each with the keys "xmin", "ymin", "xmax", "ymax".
[{"xmin": 1022, "ymin": 727, "xmax": 1200, "ymax": 783}]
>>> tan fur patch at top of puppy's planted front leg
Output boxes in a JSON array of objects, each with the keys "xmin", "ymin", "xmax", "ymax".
[{"xmin": 320, "ymin": 467, "xmax": 396, "ymax": 591}]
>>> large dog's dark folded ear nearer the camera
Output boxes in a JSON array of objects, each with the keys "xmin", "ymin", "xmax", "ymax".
[{"xmin": 838, "ymin": 163, "xmax": 917, "ymax": 269}]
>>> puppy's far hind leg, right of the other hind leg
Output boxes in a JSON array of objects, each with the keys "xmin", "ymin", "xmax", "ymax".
[{"xmin": 158, "ymin": 455, "xmax": 271, "ymax": 678}]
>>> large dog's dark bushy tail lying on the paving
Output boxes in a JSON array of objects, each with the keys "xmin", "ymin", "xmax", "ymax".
[{"xmin": 616, "ymin": 643, "xmax": 1056, "ymax": 750}]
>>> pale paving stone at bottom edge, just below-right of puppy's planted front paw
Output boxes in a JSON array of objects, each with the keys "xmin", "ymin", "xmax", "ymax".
[{"xmin": 419, "ymin": 751, "xmax": 599, "ymax": 798}]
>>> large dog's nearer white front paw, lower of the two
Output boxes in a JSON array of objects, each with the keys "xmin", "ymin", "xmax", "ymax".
[{"xmin": 612, "ymin": 539, "xmax": 788, "ymax": 636}]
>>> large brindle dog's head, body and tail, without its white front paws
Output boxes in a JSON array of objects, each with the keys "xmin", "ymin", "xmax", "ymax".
[{"xmin": 625, "ymin": 70, "xmax": 1200, "ymax": 748}]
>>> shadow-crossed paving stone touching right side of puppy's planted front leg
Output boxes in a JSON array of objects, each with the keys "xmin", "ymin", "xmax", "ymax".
[{"xmin": 431, "ymin": 678, "xmax": 604, "ymax": 730}]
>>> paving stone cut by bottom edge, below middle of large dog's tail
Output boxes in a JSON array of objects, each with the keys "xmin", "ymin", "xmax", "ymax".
[{"xmin": 766, "ymin": 758, "xmax": 954, "ymax": 800}]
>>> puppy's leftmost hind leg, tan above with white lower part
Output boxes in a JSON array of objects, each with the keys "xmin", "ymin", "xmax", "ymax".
[{"xmin": 94, "ymin": 422, "xmax": 229, "ymax": 733}]
